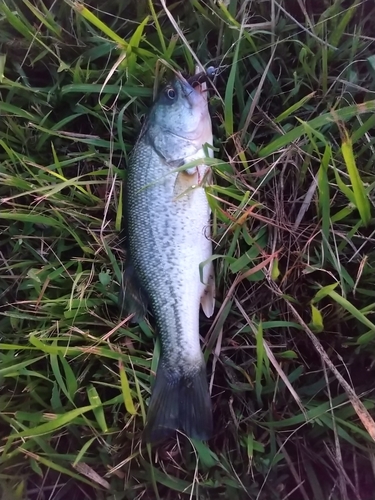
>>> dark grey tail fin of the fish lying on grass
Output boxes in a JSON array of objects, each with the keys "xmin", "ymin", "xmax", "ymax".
[{"xmin": 144, "ymin": 359, "xmax": 212, "ymax": 442}]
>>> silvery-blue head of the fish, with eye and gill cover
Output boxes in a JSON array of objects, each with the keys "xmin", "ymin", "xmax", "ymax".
[{"xmin": 148, "ymin": 75, "xmax": 212, "ymax": 161}]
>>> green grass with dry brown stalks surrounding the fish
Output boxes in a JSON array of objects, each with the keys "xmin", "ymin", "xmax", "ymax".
[{"xmin": 0, "ymin": 0, "xmax": 375, "ymax": 500}]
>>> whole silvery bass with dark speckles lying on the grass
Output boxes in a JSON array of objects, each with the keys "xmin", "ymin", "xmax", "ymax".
[{"xmin": 123, "ymin": 66, "xmax": 215, "ymax": 442}]
